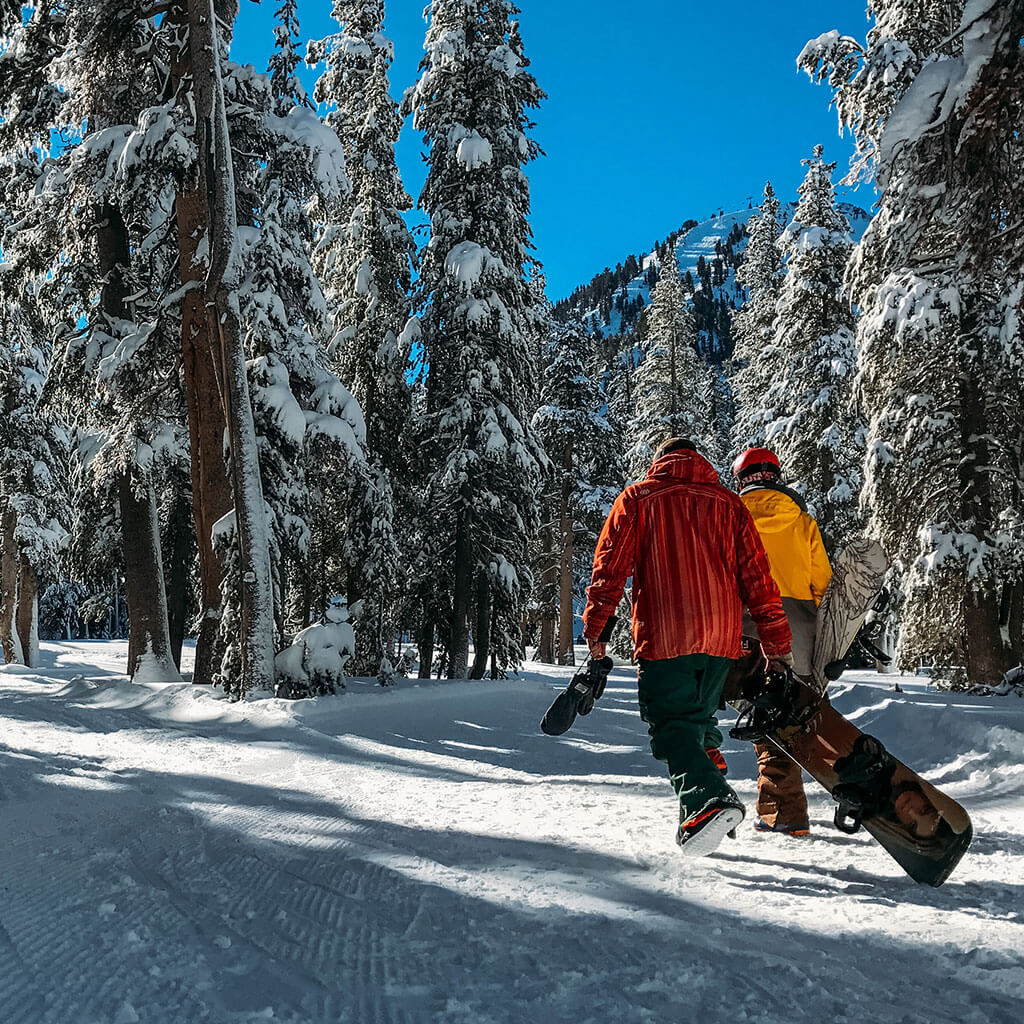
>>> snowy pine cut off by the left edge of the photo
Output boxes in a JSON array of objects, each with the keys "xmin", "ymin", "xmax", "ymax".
[{"xmin": 0, "ymin": 5, "xmax": 69, "ymax": 665}]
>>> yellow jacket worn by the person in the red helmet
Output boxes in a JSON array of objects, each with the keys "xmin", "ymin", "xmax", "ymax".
[{"xmin": 740, "ymin": 486, "xmax": 831, "ymax": 605}]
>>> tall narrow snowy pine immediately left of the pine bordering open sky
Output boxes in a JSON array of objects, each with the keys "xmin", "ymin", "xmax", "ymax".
[{"xmin": 310, "ymin": 0, "xmax": 416, "ymax": 675}]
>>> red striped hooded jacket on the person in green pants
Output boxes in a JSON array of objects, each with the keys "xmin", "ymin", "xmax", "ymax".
[{"xmin": 583, "ymin": 451, "xmax": 792, "ymax": 660}]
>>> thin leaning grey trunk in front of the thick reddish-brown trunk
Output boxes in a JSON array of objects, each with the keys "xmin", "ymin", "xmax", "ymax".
[{"xmin": 188, "ymin": 0, "xmax": 273, "ymax": 695}]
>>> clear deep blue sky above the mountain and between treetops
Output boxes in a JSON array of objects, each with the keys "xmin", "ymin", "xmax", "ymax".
[{"xmin": 232, "ymin": 0, "xmax": 871, "ymax": 299}]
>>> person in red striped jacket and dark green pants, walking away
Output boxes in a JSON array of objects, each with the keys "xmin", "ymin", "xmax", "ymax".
[{"xmin": 583, "ymin": 437, "xmax": 793, "ymax": 855}]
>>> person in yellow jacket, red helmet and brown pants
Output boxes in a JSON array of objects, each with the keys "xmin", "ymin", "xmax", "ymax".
[{"xmin": 732, "ymin": 447, "xmax": 831, "ymax": 836}]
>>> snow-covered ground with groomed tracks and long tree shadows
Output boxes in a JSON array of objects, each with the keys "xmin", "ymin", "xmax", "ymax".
[{"xmin": 0, "ymin": 642, "xmax": 1024, "ymax": 1024}]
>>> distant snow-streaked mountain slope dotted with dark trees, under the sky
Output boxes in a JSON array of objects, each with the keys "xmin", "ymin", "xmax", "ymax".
[{"xmin": 554, "ymin": 203, "xmax": 870, "ymax": 361}]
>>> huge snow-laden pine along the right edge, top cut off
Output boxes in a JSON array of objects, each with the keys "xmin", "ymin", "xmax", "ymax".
[{"xmin": 801, "ymin": 0, "xmax": 1024, "ymax": 684}]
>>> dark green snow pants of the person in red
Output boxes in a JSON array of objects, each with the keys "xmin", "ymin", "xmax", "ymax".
[{"xmin": 638, "ymin": 654, "xmax": 742, "ymax": 821}]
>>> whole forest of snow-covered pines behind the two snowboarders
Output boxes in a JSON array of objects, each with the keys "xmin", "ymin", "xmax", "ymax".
[{"xmin": 0, "ymin": 0, "xmax": 1024, "ymax": 697}]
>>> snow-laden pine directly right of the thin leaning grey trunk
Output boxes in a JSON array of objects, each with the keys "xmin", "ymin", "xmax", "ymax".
[{"xmin": 230, "ymin": 0, "xmax": 366, "ymax": 697}]
